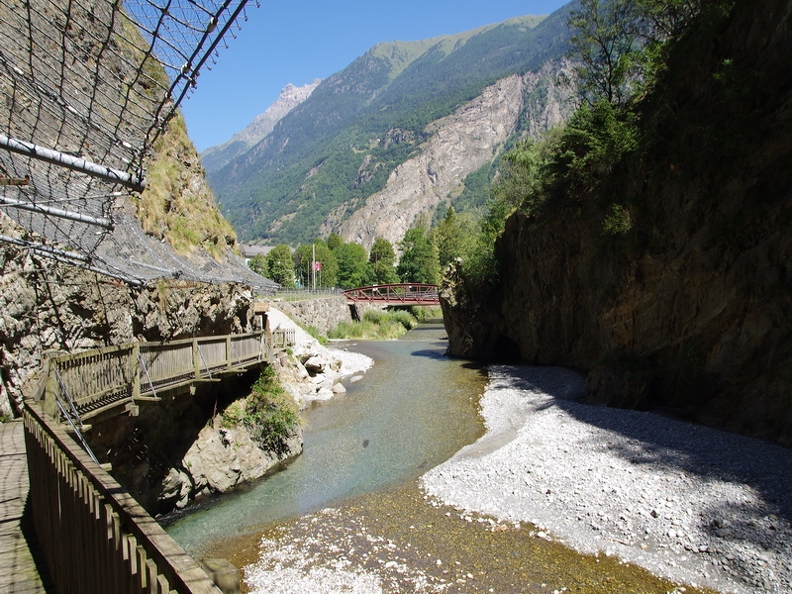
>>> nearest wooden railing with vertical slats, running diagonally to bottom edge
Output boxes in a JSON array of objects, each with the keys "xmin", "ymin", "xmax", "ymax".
[{"xmin": 24, "ymin": 402, "xmax": 221, "ymax": 594}]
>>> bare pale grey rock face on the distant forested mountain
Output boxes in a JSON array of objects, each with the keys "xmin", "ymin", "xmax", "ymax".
[{"xmin": 328, "ymin": 64, "xmax": 568, "ymax": 249}]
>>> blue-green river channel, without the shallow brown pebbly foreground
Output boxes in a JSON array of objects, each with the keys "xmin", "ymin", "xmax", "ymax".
[{"xmin": 163, "ymin": 324, "xmax": 486, "ymax": 555}]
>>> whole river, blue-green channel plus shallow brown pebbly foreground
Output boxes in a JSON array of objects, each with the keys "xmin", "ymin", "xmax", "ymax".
[{"xmin": 165, "ymin": 324, "xmax": 716, "ymax": 594}]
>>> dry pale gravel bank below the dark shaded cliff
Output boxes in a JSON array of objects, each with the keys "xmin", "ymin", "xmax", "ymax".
[{"xmin": 422, "ymin": 365, "xmax": 792, "ymax": 593}]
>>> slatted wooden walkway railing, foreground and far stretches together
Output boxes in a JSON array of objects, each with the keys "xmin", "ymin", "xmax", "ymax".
[{"xmin": 13, "ymin": 330, "xmax": 294, "ymax": 594}]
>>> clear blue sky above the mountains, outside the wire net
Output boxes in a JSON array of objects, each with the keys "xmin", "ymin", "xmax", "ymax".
[{"xmin": 182, "ymin": 0, "xmax": 567, "ymax": 151}]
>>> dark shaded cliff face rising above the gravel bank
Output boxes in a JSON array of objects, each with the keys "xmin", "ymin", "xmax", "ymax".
[{"xmin": 444, "ymin": 0, "xmax": 792, "ymax": 444}]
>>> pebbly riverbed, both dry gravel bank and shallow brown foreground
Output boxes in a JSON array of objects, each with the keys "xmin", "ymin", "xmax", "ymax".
[{"xmin": 236, "ymin": 366, "xmax": 792, "ymax": 594}]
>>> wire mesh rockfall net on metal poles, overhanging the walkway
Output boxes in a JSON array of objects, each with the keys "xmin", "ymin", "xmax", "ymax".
[{"xmin": 0, "ymin": 0, "xmax": 277, "ymax": 290}]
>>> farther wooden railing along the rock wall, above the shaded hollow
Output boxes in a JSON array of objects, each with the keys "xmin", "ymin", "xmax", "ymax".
[{"xmin": 42, "ymin": 331, "xmax": 272, "ymax": 420}]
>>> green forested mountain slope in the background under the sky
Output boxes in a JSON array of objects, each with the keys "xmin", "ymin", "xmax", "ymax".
[{"xmin": 206, "ymin": 9, "xmax": 568, "ymax": 244}]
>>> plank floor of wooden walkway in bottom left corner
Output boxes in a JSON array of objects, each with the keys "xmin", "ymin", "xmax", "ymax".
[{"xmin": 0, "ymin": 421, "xmax": 55, "ymax": 594}]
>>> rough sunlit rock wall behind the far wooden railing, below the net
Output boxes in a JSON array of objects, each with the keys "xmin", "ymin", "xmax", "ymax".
[{"xmin": 0, "ymin": 214, "xmax": 253, "ymax": 416}]
